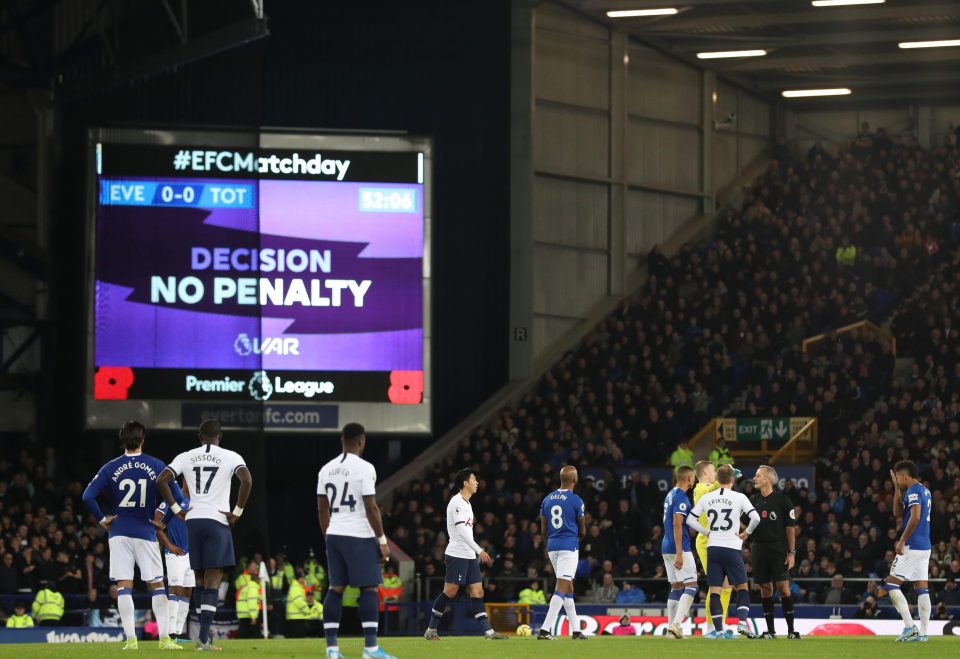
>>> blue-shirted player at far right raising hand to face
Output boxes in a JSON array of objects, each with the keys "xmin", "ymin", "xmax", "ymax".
[{"xmin": 885, "ymin": 460, "xmax": 931, "ymax": 642}]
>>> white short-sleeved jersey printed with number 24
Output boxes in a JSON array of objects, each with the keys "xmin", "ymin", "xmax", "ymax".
[{"xmin": 317, "ymin": 453, "xmax": 377, "ymax": 538}]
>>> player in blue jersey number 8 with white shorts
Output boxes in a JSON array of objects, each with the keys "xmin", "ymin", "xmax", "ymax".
[{"xmin": 537, "ymin": 465, "xmax": 587, "ymax": 641}]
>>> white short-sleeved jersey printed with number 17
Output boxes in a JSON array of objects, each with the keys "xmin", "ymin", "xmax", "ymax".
[{"xmin": 167, "ymin": 444, "xmax": 247, "ymax": 524}]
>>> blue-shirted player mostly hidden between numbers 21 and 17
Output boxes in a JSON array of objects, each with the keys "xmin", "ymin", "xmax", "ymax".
[{"xmin": 154, "ymin": 476, "xmax": 197, "ymax": 643}]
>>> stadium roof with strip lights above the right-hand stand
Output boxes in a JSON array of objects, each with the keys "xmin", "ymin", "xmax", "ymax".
[{"xmin": 563, "ymin": 0, "xmax": 960, "ymax": 107}]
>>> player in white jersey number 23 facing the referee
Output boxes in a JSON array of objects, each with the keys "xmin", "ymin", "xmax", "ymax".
[{"xmin": 687, "ymin": 465, "xmax": 760, "ymax": 638}]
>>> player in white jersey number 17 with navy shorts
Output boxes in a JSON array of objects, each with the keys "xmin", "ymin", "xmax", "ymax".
[{"xmin": 157, "ymin": 419, "xmax": 253, "ymax": 651}]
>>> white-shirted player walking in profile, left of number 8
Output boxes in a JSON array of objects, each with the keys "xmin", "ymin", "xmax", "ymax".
[{"xmin": 423, "ymin": 468, "xmax": 507, "ymax": 641}]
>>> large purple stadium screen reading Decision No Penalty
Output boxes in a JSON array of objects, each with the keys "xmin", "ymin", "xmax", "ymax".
[{"xmin": 87, "ymin": 129, "xmax": 431, "ymax": 432}]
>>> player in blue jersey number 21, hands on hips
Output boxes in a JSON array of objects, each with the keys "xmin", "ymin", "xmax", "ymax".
[{"xmin": 83, "ymin": 421, "xmax": 183, "ymax": 650}]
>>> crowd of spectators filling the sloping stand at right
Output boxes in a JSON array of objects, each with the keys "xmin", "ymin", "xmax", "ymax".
[{"xmin": 386, "ymin": 127, "xmax": 960, "ymax": 603}]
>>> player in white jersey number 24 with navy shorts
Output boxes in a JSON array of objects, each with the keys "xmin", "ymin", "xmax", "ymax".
[{"xmin": 317, "ymin": 423, "xmax": 395, "ymax": 659}]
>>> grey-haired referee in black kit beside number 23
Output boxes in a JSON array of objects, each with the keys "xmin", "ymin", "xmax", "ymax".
[{"xmin": 750, "ymin": 465, "xmax": 800, "ymax": 639}]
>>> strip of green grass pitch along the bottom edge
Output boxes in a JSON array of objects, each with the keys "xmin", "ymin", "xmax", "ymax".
[{"xmin": 0, "ymin": 636, "xmax": 960, "ymax": 659}]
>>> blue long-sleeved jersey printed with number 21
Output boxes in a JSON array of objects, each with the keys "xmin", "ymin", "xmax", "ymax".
[{"xmin": 83, "ymin": 453, "xmax": 166, "ymax": 541}]
